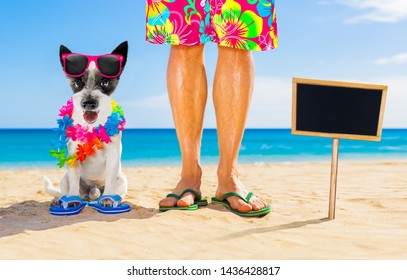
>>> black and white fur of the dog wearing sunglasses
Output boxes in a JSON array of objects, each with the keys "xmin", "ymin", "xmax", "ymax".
[{"xmin": 43, "ymin": 41, "xmax": 128, "ymax": 206}]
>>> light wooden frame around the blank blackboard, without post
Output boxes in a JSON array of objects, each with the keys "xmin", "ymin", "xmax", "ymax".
[{"xmin": 292, "ymin": 78, "xmax": 387, "ymax": 141}]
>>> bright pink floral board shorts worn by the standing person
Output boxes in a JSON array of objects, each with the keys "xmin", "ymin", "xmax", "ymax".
[{"xmin": 146, "ymin": 0, "xmax": 278, "ymax": 51}]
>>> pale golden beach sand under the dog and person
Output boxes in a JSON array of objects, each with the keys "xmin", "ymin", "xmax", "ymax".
[{"xmin": 0, "ymin": 161, "xmax": 407, "ymax": 260}]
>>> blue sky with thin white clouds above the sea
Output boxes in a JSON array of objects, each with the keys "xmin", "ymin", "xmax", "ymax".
[{"xmin": 0, "ymin": 0, "xmax": 407, "ymax": 128}]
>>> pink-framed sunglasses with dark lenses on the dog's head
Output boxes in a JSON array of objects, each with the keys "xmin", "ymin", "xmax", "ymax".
[{"xmin": 62, "ymin": 53, "xmax": 123, "ymax": 78}]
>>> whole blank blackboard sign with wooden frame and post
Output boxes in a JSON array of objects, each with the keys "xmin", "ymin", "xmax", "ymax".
[{"xmin": 292, "ymin": 78, "xmax": 387, "ymax": 220}]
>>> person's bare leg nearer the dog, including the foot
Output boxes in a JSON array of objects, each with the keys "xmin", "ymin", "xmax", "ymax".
[{"xmin": 159, "ymin": 45, "xmax": 207, "ymax": 207}]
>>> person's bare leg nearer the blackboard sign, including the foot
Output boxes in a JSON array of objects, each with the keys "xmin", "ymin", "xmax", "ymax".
[{"xmin": 213, "ymin": 46, "xmax": 266, "ymax": 212}]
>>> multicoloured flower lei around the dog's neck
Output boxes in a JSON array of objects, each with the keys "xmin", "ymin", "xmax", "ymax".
[{"xmin": 49, "ymin": 98, "xmax": 126, "ymax": 168}]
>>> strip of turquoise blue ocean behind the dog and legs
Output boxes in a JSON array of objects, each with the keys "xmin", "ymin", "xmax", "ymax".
[{"xmin": 0, "ymin": 129, "xmax": 407, "ymax": 169}]
